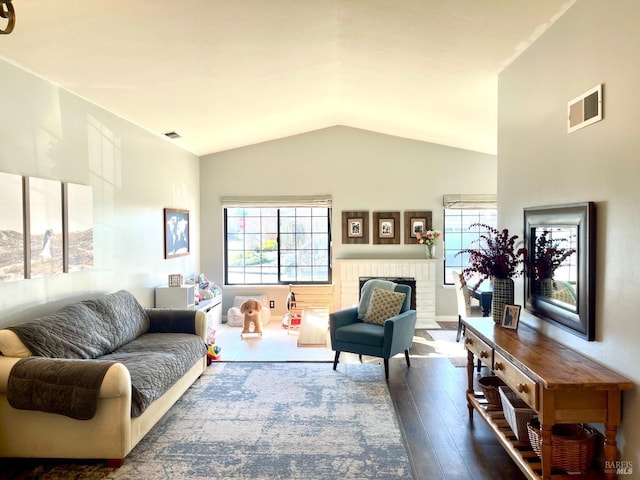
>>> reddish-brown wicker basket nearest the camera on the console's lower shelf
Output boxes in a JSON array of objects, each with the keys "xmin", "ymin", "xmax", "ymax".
[{"xmin": 527, "ymin": 420, "xmax": 595, "ymax": 472}]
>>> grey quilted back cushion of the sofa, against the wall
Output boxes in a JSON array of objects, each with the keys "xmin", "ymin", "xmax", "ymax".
[{"xmin": 8, "ymin": 290, "xmax": 149, "ymax": 359}]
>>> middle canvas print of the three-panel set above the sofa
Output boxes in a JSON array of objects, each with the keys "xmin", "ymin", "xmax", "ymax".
[{"xmin": 25, "ymin": 177, "xmax": 63, "ymax": 278}]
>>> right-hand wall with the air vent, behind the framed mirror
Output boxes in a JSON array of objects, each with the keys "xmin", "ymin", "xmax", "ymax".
[{"xmin": 498, "ymin": 0, "xmax": 640, "ymax": 464}]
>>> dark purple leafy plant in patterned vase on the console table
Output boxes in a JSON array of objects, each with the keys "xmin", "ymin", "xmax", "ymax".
[{"xmin": 456, "ymin": 223, "xmax": 527, "ymax": 323}]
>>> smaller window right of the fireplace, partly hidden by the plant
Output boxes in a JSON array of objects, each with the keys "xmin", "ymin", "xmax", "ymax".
[{"xmin": 443, "ymin": 195, "xmax": 498, "ymax": 285}]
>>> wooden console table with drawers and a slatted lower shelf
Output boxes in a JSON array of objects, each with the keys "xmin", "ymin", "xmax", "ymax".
[{"xmin": 463, "ymin": 317, "xmax": 633, "ymax": 480}]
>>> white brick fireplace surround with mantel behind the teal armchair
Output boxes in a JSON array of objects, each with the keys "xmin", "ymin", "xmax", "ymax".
[{"xmin": 336, "ymin": 258, "xmax": 438, "ymax": 328}]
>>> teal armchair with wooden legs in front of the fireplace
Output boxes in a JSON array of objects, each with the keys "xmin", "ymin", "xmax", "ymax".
[{"xmin": 329, "ymin": 280, "xmax": 416, "ymax": 380}]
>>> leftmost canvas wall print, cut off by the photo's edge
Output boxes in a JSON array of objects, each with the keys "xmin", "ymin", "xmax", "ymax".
[{"xmin": 0, "ymin": 172, "xmax": 24, "ymax": 282}]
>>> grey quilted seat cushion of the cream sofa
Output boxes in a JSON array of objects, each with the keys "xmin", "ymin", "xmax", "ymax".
[{"xmin": 100, "ymin": 333, "xmax": 207, "ymax": 417}]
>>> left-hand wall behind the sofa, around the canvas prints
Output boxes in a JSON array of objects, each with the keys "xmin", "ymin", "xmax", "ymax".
[{"xmin": 0, "ymin": 60, "xmax": 200, "ymax": 326}]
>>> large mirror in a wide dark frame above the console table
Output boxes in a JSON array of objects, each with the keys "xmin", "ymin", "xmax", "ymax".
[{"xmin": 524, "ymin": 202, "xmax": 596, "ymax": 341}]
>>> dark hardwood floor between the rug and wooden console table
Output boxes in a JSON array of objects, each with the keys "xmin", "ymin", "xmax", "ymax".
[{"xmin": 389, "ymin": 357, "xmax": 526, "ymax": 480}]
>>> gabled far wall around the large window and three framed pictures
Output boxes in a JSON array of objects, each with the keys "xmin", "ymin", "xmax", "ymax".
[{"xmin": 200, "ymin": 126, "xmax": 496, "ymax": 315}]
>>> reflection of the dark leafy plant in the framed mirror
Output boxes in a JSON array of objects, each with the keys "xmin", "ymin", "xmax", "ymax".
[{"xmin": 525, "ymin": 230, "xmax": 576, "ymax": 297}]
